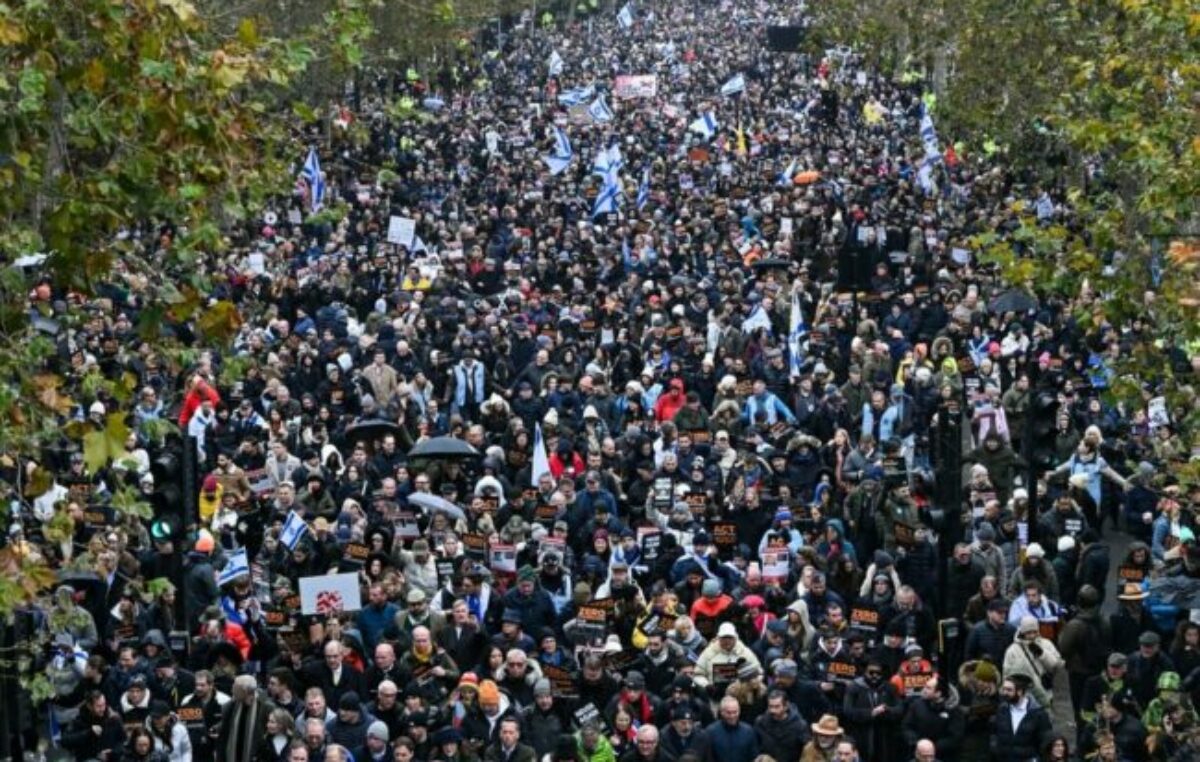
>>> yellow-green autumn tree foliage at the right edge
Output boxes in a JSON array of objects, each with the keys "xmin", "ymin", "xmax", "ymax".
[{"xmin": 814, "ymin": 0, "xmax": 1200, "ymax": 481}]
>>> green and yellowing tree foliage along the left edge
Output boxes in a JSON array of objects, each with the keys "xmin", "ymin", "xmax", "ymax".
[{"xmin": 0, "ymin": 0, "xmax": 373, "ymax": 614}]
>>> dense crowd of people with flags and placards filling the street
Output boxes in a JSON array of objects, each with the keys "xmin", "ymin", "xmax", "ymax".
[{"xmin": 10, "ymin": 0, "xmax": 1200, "ymax": 762}]
